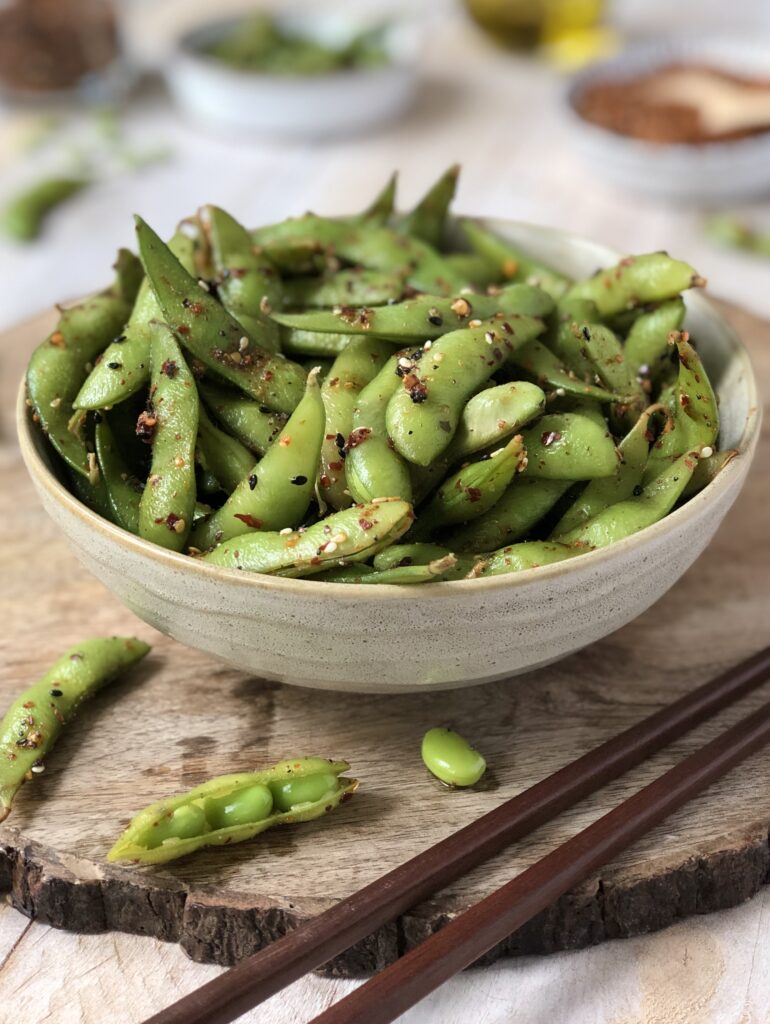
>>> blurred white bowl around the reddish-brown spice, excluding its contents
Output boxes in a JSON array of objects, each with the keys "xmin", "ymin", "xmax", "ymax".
[{"xmin": 568, "ymin": 35, "xmax": 770, "ymax": 204}]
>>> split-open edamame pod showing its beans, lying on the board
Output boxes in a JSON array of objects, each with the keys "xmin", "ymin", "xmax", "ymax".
[{"xmin": 106, "ymin": 758, "xmax": 358, "ymax": 864}]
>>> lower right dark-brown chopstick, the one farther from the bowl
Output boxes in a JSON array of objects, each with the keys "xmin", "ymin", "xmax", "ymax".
[{"xmin": 310, "ymin": 701, "xmax": 770, "ymax": 1024}]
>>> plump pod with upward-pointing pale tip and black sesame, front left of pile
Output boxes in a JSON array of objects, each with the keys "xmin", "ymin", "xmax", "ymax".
[{"xmin": 190, "ymin": 364, "xmax": 325, "ymax": 551}]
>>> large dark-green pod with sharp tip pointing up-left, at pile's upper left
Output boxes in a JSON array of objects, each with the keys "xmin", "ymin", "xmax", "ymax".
[{"xmin": 136, "ymin": 217, "xmax": 305, "ymax": 413}]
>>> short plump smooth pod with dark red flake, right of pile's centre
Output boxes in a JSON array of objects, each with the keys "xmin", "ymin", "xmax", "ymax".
[{"xmin": 522, "ymin": 413, "xmax": 618, "ymax": 480}]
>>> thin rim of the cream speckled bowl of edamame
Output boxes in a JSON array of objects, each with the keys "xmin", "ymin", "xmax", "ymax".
[{"xmin": 15, "ymin": 215, "xmax": 762, "ymax": 600}]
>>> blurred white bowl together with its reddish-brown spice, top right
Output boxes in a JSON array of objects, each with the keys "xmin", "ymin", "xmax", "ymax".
[{"xmin": 567, "ymin": 36, "xmax": 770, "ymax": 204}]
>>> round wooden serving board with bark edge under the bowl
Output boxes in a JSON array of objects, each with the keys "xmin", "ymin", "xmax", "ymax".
[{"xmin": 0, "ymin": 299, "xmax": 770, "ymax": 975}]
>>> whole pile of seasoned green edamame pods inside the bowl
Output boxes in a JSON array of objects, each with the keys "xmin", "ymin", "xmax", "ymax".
[{"xmin": 27, "ymin": 167, "xmax": 735, "ymax": 584}]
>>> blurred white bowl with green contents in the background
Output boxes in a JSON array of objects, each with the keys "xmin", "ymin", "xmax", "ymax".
[{"xmin": 165, "ymin": 9, "xmax": 419, "ymax": 137}]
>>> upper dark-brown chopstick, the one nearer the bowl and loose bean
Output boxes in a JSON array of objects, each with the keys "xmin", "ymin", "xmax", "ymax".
[{"xmin": 144, "ymin": 647, "xmax": 770, "ymax": 1024}]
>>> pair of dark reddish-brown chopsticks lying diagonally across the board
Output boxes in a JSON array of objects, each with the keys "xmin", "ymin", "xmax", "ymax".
[{"xmin": 144, "ymin": 647, "xmax": 770, "ymax": 1024}]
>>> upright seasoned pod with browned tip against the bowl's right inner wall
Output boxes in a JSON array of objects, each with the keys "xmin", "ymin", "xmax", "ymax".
[{"xmin": 642, "ymin": 332, "xmax": 719, "ymax": 485}]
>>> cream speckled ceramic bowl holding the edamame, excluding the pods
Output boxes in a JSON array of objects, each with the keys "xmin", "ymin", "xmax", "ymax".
[{"xmin": 17, "ymin": 221, "xmax": 761, "ymax": 693}]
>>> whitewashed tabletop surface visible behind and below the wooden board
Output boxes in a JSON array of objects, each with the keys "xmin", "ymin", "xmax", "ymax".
[{"xmin": 0, "ymin": 0, "xmax": 770, "ymax": 1024}]
